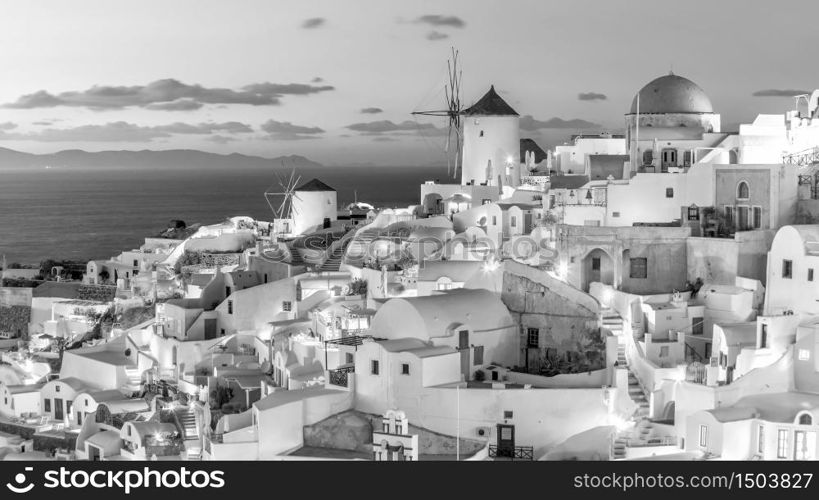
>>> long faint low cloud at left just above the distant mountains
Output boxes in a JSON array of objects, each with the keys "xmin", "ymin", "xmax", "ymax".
[{"xmin": 0, "ymin": 121, "xmax": 253, "ymax": 142}]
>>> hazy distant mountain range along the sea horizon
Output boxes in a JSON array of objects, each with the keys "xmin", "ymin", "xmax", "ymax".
[{"xmin": 0, "ymin": 148, "xmax": 324, "ymax": 170}]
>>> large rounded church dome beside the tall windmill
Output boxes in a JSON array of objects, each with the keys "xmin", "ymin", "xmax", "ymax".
[{"xmin": 631, "ymin": 73, "xmax": 714, "ymax": 114}]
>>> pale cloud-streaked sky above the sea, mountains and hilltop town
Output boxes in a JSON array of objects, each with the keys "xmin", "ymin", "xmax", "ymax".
[{"xmin": 0, "ymin": 0, "xmax": 819, "ymax": 166}]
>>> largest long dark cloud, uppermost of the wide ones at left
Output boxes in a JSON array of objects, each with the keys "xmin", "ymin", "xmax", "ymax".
[{"xmin": 3, "ymin": 78, "xmax": 334, "ymax": 110}]
